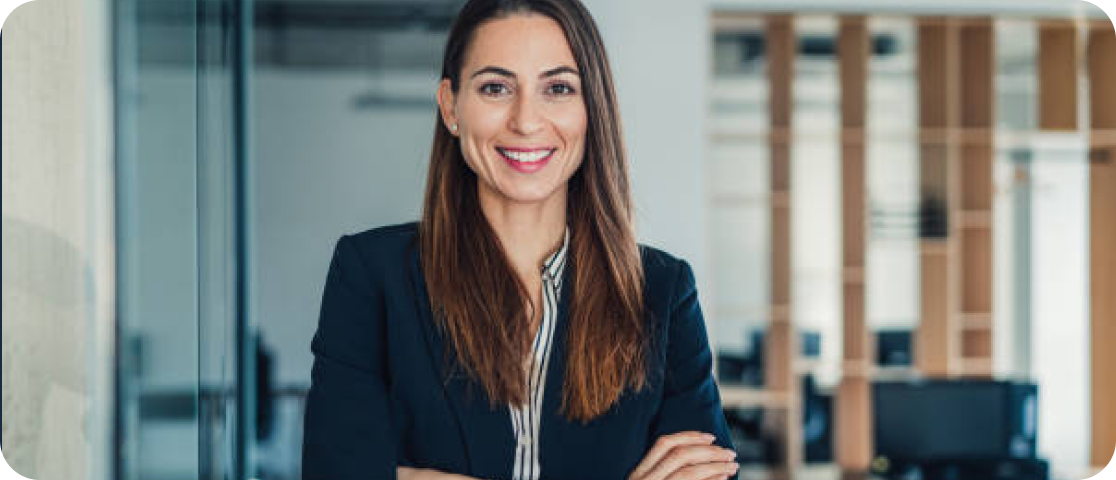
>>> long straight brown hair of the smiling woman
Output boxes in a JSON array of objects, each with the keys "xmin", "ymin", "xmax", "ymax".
[{"xmin": 420, "ymin": 0, "xmax": 651, "ymax": 423}]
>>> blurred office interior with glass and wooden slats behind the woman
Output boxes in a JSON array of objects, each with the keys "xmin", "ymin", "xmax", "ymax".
[{"xmin": 2, "ymin": 0, "xmax": 1116, "ymax": 480}]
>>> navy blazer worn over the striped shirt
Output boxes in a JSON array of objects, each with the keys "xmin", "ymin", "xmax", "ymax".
[{"xmin": 302, "ymin": 223, "xmax": 732, "ymax": 480}]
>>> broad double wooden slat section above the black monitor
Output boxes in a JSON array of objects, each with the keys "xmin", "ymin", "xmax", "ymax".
[{"xmin": 915, "ymin": 18, "xmax": 995, "ymax": 377}]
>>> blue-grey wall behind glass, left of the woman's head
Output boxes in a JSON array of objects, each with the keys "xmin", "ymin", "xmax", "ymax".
[{"xmin": 251, "ymin": 69, "xmax": 436, "ymax": 385}]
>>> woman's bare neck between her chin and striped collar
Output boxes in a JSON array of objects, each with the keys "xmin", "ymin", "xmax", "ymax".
[{"xmin": 478, "ymin": 185, "xmax": 566, "ymax": 285}]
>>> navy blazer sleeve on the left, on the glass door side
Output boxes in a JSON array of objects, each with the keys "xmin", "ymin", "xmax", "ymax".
[{"xmin": 302, "ymin": 236, "xmax": 396, "ymax": 480}]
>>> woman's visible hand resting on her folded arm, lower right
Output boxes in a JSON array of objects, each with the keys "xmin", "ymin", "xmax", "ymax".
[{"xmin": 627, "ymin": 432, "xmax": 740, "ymax": 480}]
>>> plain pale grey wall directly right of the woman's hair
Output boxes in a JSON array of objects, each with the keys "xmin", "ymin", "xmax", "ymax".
[{"xmin": 585, "ymin": 0, "xmax": 712, "ymax": 273}]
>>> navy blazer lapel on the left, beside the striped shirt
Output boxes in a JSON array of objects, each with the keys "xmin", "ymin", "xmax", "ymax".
[{"xmin": 411, "ymin": 248, "xmax": 515, "ymax": 478}]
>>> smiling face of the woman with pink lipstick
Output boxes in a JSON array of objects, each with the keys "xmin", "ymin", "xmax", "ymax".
[{"xmin": 439, "ymin": 15, "xmax": 588, "ymax": 203}]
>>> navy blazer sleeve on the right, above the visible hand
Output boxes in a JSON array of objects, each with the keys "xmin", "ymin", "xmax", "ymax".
[{"xmin": 650, "ymin": 260, "xmax": 734, "ymax": 478}]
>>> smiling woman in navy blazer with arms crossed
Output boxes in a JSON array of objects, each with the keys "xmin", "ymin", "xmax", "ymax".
[{"xmin": 302, "ymin": 0, "xmax": 737, "ymax": 480}]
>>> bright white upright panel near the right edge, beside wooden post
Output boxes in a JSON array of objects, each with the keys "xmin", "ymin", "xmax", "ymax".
[{"xmin": 1031, "ymin": 138, "xmax": 1090, "ymax": 478}]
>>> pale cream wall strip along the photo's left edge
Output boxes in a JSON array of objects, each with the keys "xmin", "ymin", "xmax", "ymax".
[{"xmin": 2, "ymin": 0, "xmax": 113, "ymax": 479}]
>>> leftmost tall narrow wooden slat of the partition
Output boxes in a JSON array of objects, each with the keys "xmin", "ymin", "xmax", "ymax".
[{"xmin": 764, "ymin": 15, "xmax": 802, "ymax": 471}]
